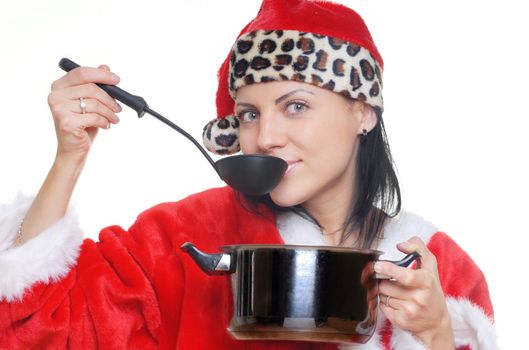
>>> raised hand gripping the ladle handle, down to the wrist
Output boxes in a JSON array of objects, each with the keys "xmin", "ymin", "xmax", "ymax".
[{"xmin": 48, "ymin": 65, "xmax": 121, "ymax": 162}]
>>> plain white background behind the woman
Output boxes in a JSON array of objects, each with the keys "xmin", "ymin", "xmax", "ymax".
[{"xmin": 0, "ymin": 0, "xmax": 529, "ymax": 349}]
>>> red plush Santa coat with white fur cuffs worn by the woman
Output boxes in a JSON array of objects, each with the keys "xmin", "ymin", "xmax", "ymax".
[{"xmin": 0, "ymin": 187, "xmax": 496, "ymax": 350}]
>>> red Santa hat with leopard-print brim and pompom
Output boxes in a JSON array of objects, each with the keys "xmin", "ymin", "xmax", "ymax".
[{"xmin": 202, "ymin": 0, "xmax": 383, "ymax": 155}]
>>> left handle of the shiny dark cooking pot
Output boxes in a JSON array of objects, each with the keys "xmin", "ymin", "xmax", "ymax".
[{"xmin": 180, "ymin": 242, "xmax": 235, "ymax": 275}]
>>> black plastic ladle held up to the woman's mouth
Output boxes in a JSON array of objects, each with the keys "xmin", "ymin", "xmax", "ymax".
[{"xmin": 59, "ymin": 58, "xmax": 288, "ymax": 195}]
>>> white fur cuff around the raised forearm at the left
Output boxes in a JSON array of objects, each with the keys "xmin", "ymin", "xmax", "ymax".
[{"xmin": 0, "ymin": 199, "xmax": 83, "ymax": 302}]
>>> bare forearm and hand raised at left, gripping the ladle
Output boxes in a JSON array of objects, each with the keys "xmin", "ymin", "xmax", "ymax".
[{"xmin": 14, "ymin": 65, "xmax": 121, "ymax": 245}]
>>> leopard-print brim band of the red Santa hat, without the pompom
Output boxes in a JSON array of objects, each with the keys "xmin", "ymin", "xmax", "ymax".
[{"xmin": 229, "ymin": 30, "xmax": 383, "ymax": 110}]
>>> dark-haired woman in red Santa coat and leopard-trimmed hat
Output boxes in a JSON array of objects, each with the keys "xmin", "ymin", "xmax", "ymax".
[{"xmin": 0, "ymin": 0, "xmax": 495, "ymax": 349}]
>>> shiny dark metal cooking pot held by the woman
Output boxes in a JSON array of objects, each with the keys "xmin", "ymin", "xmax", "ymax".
[{"xmin": 182, "ymin": 243, "xmax": 419, "ymax": 343}]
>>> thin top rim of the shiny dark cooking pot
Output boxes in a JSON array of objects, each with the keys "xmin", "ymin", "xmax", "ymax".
[{"xmin": 220, "ymin": 244, "xmax": 384, "ymax": 256}]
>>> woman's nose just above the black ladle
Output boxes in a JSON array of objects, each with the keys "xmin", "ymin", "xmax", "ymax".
[{"xmin": 257, "ymin": 112, "xmax": 287, "ymax": 154}]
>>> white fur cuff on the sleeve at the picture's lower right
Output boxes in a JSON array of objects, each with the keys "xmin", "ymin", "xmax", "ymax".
[{"xmin": 446, "ymin": 297, "xmax": 499, "ymax": 350}]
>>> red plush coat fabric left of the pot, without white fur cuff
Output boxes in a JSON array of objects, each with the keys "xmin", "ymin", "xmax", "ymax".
[{"xmin": 0, "ymin": 189, "xmax": 335, "ymax": 350}]
